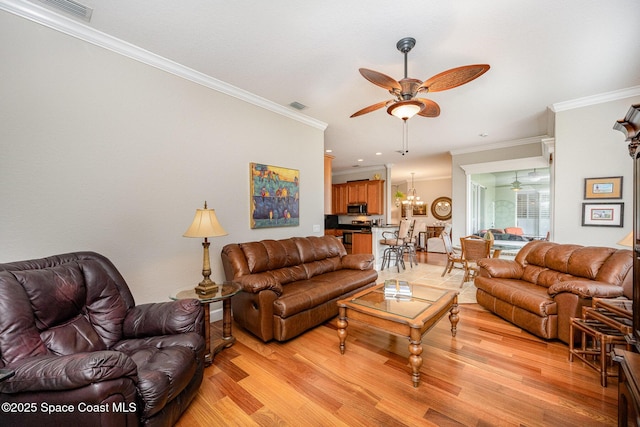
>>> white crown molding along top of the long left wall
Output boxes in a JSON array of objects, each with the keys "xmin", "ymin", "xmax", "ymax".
[{"xmin": 0, "ymin": 0, "xmax": 328, "ymax": 131}]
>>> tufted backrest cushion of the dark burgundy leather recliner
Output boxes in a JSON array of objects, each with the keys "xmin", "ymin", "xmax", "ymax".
[{"xmin": 0, "ymin": 260, "xmax": 127, "ymax": 363}]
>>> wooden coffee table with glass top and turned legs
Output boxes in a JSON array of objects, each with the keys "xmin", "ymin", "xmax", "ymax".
[{"xmin": 337, "ymin": 284, "xmax": 459, "ymax": 387}]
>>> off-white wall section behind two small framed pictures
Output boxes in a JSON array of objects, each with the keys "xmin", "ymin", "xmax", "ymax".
[{"xmin": 554, "ymin": 96, "xmax": 640, "ymax": 247}]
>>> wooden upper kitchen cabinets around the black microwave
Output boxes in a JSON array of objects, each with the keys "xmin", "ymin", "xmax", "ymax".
[{"xmin": 331, "ymin": 179, "xmax": 384, "ymax": 215}]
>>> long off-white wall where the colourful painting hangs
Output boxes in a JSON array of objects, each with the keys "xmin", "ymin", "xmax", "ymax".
[{"xmin": 0, "ymin": 12, "xmax": 324, "ymax": 303}]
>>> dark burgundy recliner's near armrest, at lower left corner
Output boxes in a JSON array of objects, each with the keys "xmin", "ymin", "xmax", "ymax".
[{"xmin": 0, "ymin": 351, "xmax": 138, "ymax": 393}]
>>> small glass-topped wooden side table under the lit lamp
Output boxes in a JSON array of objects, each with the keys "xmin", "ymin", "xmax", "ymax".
[{"xmin": 171, "ymin": 282, "xmax": 242, "ymax": 366}]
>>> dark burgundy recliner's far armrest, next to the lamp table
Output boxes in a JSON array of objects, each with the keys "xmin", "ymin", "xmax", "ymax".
[{"xmin": 123, "ymin": 298, "xmax": 203, "ymax": 338}]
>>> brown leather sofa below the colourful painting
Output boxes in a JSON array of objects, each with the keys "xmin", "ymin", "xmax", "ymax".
[{"xmin": 221, "ymin": 236, "xmax": 378, "ymax": 342}]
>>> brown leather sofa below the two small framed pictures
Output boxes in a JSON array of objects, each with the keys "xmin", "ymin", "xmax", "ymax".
[{"xmin": 474, "ymin": 241, "xmax": 633, "ymax": 343}]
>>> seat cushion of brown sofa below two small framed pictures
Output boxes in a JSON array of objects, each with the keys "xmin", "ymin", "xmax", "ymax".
[{"xmin": 475, "ymin": 277, "xmax": 558, "ymax": 317}]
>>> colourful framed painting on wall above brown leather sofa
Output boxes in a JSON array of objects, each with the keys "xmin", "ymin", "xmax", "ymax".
[{"xmin": 249, "ymin": 163, "xmax": 300, "ymax": 228}]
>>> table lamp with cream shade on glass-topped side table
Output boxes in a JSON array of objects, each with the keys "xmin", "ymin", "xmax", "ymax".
[{"xmin": 183, "ymin": 201, "xmax": 228, "ymax": 298}]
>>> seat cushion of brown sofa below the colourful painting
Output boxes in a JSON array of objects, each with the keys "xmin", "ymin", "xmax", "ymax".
[{"xmin": 273, "ymin": 270, "xmax": 378, "ymax": 318}]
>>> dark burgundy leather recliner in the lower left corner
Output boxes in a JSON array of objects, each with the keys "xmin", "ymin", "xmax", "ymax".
[{"xmin": 0, "ymin": 252, "xmax": 204, "ymax": 427}]
